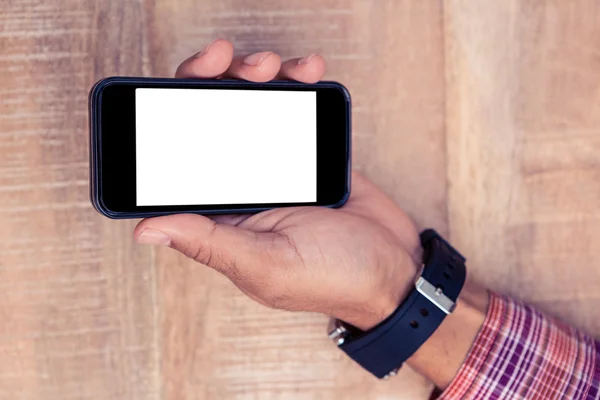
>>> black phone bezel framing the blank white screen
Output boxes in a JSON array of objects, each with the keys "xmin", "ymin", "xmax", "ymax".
[{"xmin": 89, "ymin": 77, "xmax": 351, "ymax": 219}]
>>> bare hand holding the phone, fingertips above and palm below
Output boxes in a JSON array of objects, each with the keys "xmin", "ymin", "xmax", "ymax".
[{"xmin": 134, "ymin": 40, "xmax": 421, "ymax": 330}]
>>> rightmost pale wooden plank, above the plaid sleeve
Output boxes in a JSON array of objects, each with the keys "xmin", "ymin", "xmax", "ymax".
[{"xmin": 444, "ymin": 0, "xmax": 600, "ymax": 335}]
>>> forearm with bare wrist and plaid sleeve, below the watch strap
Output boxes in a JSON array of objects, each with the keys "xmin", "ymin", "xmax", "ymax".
[{"xmin": 408, "ymin": 285, "xmax": 600, "ymax": 400}]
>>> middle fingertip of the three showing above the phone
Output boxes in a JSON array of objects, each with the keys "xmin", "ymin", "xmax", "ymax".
[{"xmin": 223, "ymin": 51, "xmax": 281, "ymax": 82}]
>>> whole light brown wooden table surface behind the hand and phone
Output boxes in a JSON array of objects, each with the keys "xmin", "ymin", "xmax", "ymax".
[{"xmin": 0, "ymin": 0, "xmax": 600, "ymax": 400}]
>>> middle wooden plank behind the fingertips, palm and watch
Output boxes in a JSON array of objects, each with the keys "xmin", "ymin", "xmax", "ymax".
[{"xmin": 149, "ymin": 0, "xmax": 446, "ymax": 400}]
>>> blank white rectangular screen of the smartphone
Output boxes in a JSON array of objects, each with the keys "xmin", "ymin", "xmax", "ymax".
[{"xmin": 135, "ymin": 88, "xmax": 317, "ymax": 206}]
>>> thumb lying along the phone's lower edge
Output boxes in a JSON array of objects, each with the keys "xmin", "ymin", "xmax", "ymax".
[{"xmin": 134, "ymin": 214, "xmax": 273, "ymax": 278}]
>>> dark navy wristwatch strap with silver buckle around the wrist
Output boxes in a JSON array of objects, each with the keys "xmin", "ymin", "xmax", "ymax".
[{"xmin": 329, "ymin": 229, "xmax": 467, "ymax": 379}]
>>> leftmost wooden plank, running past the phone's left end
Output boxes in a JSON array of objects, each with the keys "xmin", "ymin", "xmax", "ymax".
[{"xmin": 0, "ymin": 0, "xmax": 159, "ymax": 400}]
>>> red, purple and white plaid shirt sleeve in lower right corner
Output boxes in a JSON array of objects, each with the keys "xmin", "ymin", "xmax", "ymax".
[{"xmin": 438, "ymin": 293, "xmax": 600, "ymax": 400}]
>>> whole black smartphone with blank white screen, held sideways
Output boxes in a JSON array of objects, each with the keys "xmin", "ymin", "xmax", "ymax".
[{"xmin": 89, "ymin": 77, "xmax": 351, "ymax": 218}]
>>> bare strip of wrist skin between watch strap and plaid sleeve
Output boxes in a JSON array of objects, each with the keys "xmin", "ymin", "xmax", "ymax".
[{"xmin": 407, "ymin": 283, "xmax": 489, "ymax": 389}]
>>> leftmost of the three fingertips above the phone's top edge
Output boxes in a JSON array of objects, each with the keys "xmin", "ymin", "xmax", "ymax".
[{"xmin": 175, "ymin": 39, "xmax": 233, "ymax": 78}]
